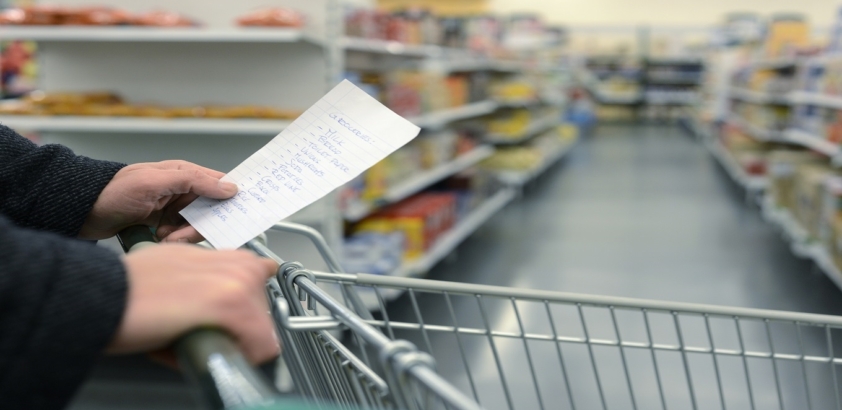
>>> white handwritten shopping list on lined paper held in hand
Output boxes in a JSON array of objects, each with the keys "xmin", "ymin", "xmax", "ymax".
[{"xmin": 181, "ymin": 80, "xmax": 420, "ymax": 249}]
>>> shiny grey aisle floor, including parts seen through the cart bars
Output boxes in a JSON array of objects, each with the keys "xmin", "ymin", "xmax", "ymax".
[{"xmin": 390, "ymin": 126, "xmax": 842, "ymax": 409}]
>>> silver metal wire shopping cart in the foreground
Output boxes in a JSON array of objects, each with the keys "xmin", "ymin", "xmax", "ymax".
[{"xmin": 120, "ymin": 223, "xmax": 842, "ymax": 409}]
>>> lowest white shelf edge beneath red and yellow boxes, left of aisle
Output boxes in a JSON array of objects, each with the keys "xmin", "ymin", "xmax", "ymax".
[{"xmin": 394, "ymin": 189, "xmax": 515, "ymax": 277}]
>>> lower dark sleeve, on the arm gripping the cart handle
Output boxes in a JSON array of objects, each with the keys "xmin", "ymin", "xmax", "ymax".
[{"xmin": 0, "ymin": 216, "xmax": 127, "ymax": 410}]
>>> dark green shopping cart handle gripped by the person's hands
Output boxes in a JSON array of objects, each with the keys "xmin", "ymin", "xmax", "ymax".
[{"xmin": 117, "ymin": 226, "xmax": 278, "ymax": 410}]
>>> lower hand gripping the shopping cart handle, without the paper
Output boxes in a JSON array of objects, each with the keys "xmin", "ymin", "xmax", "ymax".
[{"xmin": 107, "ymin": 244, "xmax": 280, "ymax": 363}]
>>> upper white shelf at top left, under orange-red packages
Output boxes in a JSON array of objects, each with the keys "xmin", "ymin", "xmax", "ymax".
[{"xmin": 0, "ymin": 26, "xmax": 314, "ymax": 43}]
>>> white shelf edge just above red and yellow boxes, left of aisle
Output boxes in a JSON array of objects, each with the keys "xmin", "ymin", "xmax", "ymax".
[{"xmin": 344, "ymin": 145, "xmax": 494, "ymax": 222}]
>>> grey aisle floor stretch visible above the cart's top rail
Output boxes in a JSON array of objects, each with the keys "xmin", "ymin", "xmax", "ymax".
[{"xmin": 432, "ymin": 122, "xmax": 842, "ymax": 314}]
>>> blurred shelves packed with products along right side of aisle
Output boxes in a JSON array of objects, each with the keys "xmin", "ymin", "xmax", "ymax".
[{"xmin": 710, "ymin": 4, "xmax": 842, "ymax": 283}]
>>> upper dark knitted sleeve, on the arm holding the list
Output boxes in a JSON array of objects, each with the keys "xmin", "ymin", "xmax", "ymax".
[{"xmin": 0, "ymin": 125, "xmax": 124, "ymax": 237}]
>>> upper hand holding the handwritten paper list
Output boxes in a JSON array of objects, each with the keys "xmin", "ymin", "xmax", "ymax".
[{"xmin": 79, "ymin": 161, "xmax": 237, "ymax": 243}]
